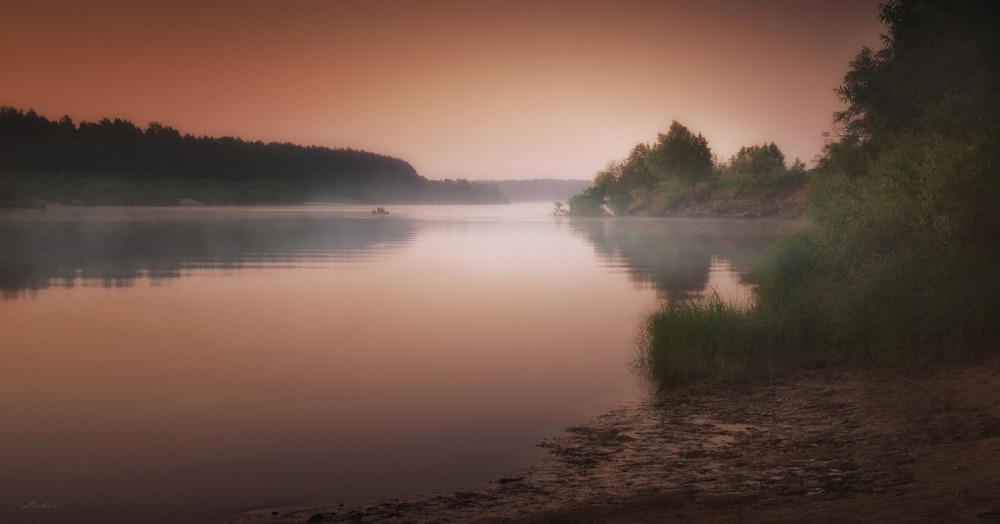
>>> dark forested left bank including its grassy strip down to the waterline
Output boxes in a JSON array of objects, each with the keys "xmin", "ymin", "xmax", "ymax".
[{"xmin": 0, "ymin": 107, "xmax": 504, "ymax": 207}]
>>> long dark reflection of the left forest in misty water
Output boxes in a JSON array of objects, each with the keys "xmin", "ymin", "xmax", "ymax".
[{"xmin": 0, "ymin": 214, "xmax": 414, "ymax": 298}]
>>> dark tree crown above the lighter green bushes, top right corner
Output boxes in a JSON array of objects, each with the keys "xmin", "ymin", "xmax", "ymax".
[{"xmin": 835, "ymin": 0, "xmax": 1000, "ymax": 161}]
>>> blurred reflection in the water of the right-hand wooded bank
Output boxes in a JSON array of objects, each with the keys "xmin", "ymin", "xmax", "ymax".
[{"xmin": 570, "ymin": 217, "xmax": 800, "ymax": 300}]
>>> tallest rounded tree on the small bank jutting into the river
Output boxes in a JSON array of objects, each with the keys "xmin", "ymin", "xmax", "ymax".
[{"xmin": 645, "ymin": 120, "xmax": 713, "ymax": 184}]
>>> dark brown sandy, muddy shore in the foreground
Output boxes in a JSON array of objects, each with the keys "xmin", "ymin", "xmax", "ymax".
[{"xmin": 232, "ymin": 359, "xmax": 1000, "ymax": 524}]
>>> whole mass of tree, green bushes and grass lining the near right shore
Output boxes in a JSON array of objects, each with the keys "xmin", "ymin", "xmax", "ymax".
[{"xmin": 644, "ymin": 0, "xmax": 1000, "ymax": 384}]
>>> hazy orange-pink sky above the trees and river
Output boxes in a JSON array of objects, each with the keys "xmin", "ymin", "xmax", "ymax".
[{"xmin": 0, "ymin": 0, "xmax": 885, "ymax": 180}]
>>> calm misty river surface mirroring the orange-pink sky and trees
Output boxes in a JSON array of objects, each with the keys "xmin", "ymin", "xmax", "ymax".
[{"xmin": 0, "ymin": 205, "xmax": 797, "ymax": 523}]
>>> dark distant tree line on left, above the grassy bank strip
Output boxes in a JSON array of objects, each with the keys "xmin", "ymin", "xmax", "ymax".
[{"xmin": 0, "ymin": 107, "xmax": 503, "ymax": 202}]
